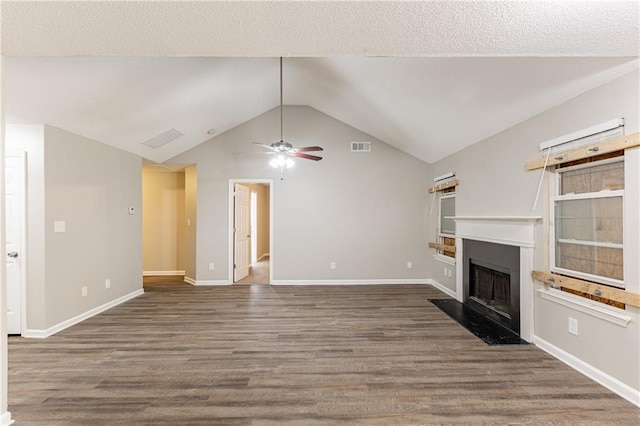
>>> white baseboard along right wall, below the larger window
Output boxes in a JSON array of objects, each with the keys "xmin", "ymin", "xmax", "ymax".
[{"xmin": 533, "ymin": 336, "xmax": 640, "ymax": 407}]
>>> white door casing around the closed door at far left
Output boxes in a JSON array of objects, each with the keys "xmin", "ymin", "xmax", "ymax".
[{"xmin": 3, "ymin": 151, "xmax": 28, "ymax": 336}]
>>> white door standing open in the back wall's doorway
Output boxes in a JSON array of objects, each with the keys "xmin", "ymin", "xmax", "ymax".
[{"xmin": 233, "ymin": 183, "xmax": 251, "ymax": 282}]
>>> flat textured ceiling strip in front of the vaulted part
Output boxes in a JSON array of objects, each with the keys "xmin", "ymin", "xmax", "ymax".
[{"xmin": 2, "ymin": 0, "xmax": 639, "ymax": 57}]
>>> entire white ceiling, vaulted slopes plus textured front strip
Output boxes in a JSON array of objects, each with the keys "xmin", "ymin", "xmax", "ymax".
[{"xmin": 2, "ymin": 1, "xmax": 640, "ymax": 162}]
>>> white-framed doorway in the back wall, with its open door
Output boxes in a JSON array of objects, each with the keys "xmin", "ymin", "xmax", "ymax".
[{"xmin": 229, "ymin": 179, "xmax": 273, "ymax": 284}]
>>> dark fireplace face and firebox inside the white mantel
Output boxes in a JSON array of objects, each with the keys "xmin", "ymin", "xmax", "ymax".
[{"xmin": 463, "ymin": 240, "xmax": 520, "ymax": 334}]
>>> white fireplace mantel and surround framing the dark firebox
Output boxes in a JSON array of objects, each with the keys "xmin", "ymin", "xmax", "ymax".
[{"xmin": 453, "ymin": 216, "xmax": 541, "ymax": 342}]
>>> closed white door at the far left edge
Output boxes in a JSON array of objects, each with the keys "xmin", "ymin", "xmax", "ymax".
[{"xmin": 5, "ymin": 154, "xmax": 25, "ymax": 334}]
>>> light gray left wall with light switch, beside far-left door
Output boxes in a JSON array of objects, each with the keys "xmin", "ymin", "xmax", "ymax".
[{"xmin": 7, "ymin": 126, "xmax": 142, "ymax": 330}]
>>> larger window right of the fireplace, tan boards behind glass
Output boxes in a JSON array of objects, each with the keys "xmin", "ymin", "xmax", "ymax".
[{"xmin": 551, "ymin": 156, "xmax": 624, "ymax": 288}]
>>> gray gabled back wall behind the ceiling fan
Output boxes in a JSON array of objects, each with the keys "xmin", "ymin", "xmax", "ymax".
[{"xmin": 170, "ymin": 106, "xmax": 429, "ymax": 281}]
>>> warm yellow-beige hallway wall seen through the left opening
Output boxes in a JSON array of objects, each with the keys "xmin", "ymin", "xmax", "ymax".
[{"xmin": 142, "ymin": 168, "xmax": 186, "ymax": 275}]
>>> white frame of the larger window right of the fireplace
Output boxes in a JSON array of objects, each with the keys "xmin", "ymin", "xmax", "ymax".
[{"xmin": 549, "ymin": 155, "xmax": 627, "ymax": 290}]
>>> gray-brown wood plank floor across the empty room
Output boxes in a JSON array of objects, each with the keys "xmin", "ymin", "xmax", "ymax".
[{"xmin": 9, "ymin": 280, "xmax": 640, "ymax": 426}]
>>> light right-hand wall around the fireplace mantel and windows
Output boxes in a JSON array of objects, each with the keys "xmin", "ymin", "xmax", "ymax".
[{"xmin": 429, "ymin": 71, "xmax": 640, "ymax": 400}]
